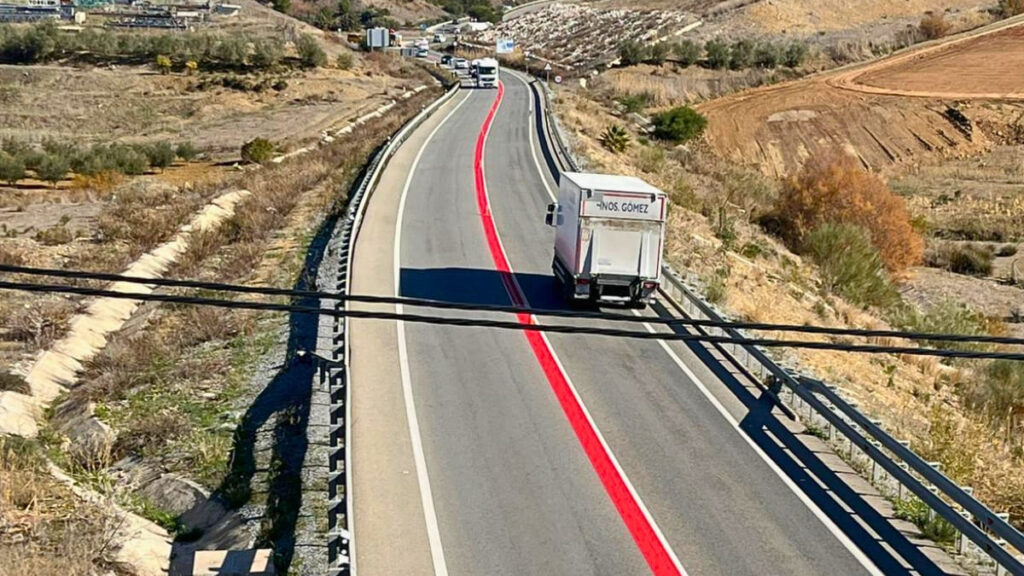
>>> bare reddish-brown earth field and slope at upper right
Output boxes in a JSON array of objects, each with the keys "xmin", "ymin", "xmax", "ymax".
[{"xmin": 698, "ymin": 18, "xmax": 1024, "ymax": 176}]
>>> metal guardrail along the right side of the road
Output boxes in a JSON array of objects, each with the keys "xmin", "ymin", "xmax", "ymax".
[{"xmin": 530, "ymin": 73, "xmax": 1024, "ymax": 576}]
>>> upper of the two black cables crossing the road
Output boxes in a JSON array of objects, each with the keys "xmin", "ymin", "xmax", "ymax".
[{"xmin": 0, "ymin": 264, "xmax": 1024, "ymax": 345}]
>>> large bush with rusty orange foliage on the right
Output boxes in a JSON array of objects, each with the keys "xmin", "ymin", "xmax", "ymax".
[{"xmin": 775, "ymin": 154, "xmax": 925, "ymax": 273}]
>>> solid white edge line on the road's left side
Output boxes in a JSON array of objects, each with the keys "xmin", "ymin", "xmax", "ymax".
[{"xmin": 393, "ymin": 92, "xmax": 471, "ymax": 576}]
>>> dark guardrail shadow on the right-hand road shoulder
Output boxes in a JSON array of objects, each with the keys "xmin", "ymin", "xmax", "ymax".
[{"xmin": 654, "ymin": 304, "xmax": 945, "ymax": 576}]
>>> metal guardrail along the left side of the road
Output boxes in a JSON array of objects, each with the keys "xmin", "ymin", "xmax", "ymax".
[{"xmin": 328, "ymin": 84, "xmax": 459, "ymax": 576}]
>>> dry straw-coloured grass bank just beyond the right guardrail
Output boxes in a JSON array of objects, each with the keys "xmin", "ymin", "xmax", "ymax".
[{"xmin": 556, "ymin": 80, "xmax": 1024, "ymax": 522}]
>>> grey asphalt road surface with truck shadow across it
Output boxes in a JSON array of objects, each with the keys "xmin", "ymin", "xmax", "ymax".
[{"xmin": 351, "ymin": 75, "xmax": 921, "ymax": 576}]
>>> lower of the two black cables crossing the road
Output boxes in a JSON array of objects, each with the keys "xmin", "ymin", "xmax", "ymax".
[{"xmin": 0, "ymin": 281, "xmax": 1024, "ymax": 361}]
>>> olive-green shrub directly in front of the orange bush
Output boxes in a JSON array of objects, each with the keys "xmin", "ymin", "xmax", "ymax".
[{"xmin": 803, "ymin": 222, "xmax": 896, "ymax": 306}]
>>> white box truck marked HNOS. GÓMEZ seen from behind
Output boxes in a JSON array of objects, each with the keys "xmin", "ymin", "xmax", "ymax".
[{"xmin": 547, "ymin": 172, "xmax": 668, "ymax": 307}]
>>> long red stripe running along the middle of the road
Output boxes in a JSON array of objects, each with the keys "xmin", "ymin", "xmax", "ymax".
[{"xmin": 473, "ymin": 83, "xmax": 685, "ymax": 576}]
